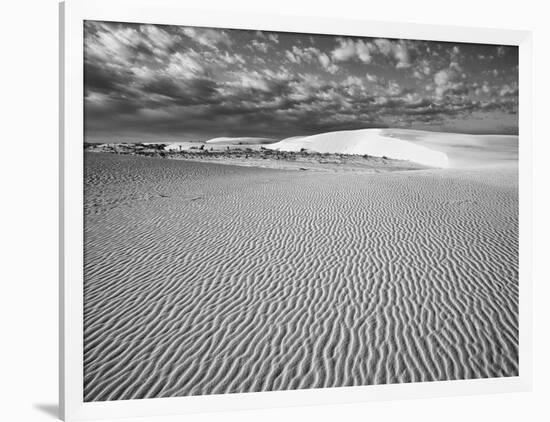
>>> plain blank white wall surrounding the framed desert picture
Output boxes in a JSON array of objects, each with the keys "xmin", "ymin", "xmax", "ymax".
[{"xmin": 0, "ymin": 0, "xmax": 550, "ymax": 422}]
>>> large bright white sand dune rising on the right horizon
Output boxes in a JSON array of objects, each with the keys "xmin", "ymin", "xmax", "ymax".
[{"xmin": 266, "ymin": 129, "xmax": 518, "ymax": 168}]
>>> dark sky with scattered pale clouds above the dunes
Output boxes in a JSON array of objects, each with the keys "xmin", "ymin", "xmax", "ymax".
[{"xmin": 84, "ymin": 21, "xmax": 518, "ymax": 142}]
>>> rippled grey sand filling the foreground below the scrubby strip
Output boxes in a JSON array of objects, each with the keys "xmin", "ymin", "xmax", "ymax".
[{"xmin": 84, "ymin": 153, "xmax": 518, "ymax": 401}]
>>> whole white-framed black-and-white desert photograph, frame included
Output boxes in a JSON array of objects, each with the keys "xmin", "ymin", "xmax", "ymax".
[{"xmin": 60, "ymin": 0, "xmax": 531, "ymax": 421}]
